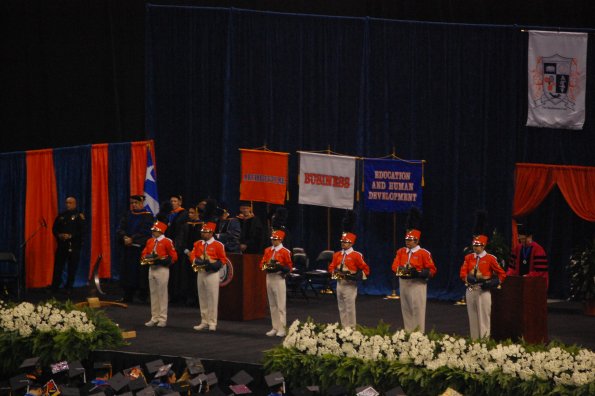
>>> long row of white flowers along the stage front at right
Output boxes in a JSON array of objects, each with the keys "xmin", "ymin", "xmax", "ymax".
[{"xmin": 283, "ymin": 320, "xmax": 595, "ymax": 386}]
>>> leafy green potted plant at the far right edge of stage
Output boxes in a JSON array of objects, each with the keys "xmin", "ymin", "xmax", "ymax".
[{"xmin": 568, "ymin": 238, "xmax": 595, "ymax": 316}]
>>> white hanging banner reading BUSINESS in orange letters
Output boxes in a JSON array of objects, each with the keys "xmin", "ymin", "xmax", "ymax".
[{"xmin": 298, "ymin": 151, "xmax": 356, "ymax": 209}]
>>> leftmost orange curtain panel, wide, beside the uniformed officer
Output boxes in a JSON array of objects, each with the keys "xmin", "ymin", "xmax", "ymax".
[{"xmin": 25, "ymin": 149, "xmax": 58, "ymax": 288}]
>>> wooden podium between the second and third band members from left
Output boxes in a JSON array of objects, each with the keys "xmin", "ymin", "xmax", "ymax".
[{"xmin": 219, "ymin": 254, "xmax": 267, "ymax": 321}]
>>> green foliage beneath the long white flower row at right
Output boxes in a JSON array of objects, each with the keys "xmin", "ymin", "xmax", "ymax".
[{"xmin": 264, "ymin": 322, "xmax": 595, "ymax": 396}]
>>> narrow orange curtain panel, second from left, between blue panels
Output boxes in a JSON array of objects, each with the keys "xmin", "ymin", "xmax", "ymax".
[{"xmin": 89, "ymin": 144, "xmax": 111, "ymax": 278}]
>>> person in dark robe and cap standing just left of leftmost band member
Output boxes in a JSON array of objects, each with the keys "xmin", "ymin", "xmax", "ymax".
[{"xmin": 116, "ymin": 195, "xmax": 154, "ymax": 303}]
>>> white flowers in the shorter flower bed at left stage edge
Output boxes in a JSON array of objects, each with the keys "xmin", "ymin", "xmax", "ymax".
[{"xmin": 0, "ymin": 301, "xmax": 95, "ymax": 337}]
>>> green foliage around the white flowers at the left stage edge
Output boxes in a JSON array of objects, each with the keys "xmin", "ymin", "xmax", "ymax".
[{"xmin": 0, "ymin": 300, "xmax": 125, "ymax": 378}]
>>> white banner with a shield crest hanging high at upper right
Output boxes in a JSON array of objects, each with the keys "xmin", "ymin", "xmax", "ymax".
[{"xmin": 527, "ymin": 31, "xmax": 587, "ymax": 129}]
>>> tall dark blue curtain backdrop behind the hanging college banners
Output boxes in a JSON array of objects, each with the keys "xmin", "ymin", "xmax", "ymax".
[{"xmin": 146, "ymin": 5, "xmax": 595, "ymax": 299}]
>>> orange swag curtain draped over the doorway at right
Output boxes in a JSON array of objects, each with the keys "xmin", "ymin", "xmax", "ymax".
[{"xmin": 512, "ymin": 164, "xmax": 595, "ymax": 244}]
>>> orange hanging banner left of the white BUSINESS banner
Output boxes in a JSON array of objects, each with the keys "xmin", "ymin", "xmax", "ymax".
[{"xmin": 240, "ymin": 149, "xmax": 289, "ymax": 205}]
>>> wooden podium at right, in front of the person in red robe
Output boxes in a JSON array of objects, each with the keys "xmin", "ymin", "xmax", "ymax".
[{"xmin": 491, "ymin": 276, "xmax": 548, "ymax": 344}]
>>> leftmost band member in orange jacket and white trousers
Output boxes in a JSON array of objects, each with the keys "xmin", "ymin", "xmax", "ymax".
[{"xmin": 141, "ymin": 221, "xmax": 178, "ymax": 327}]
